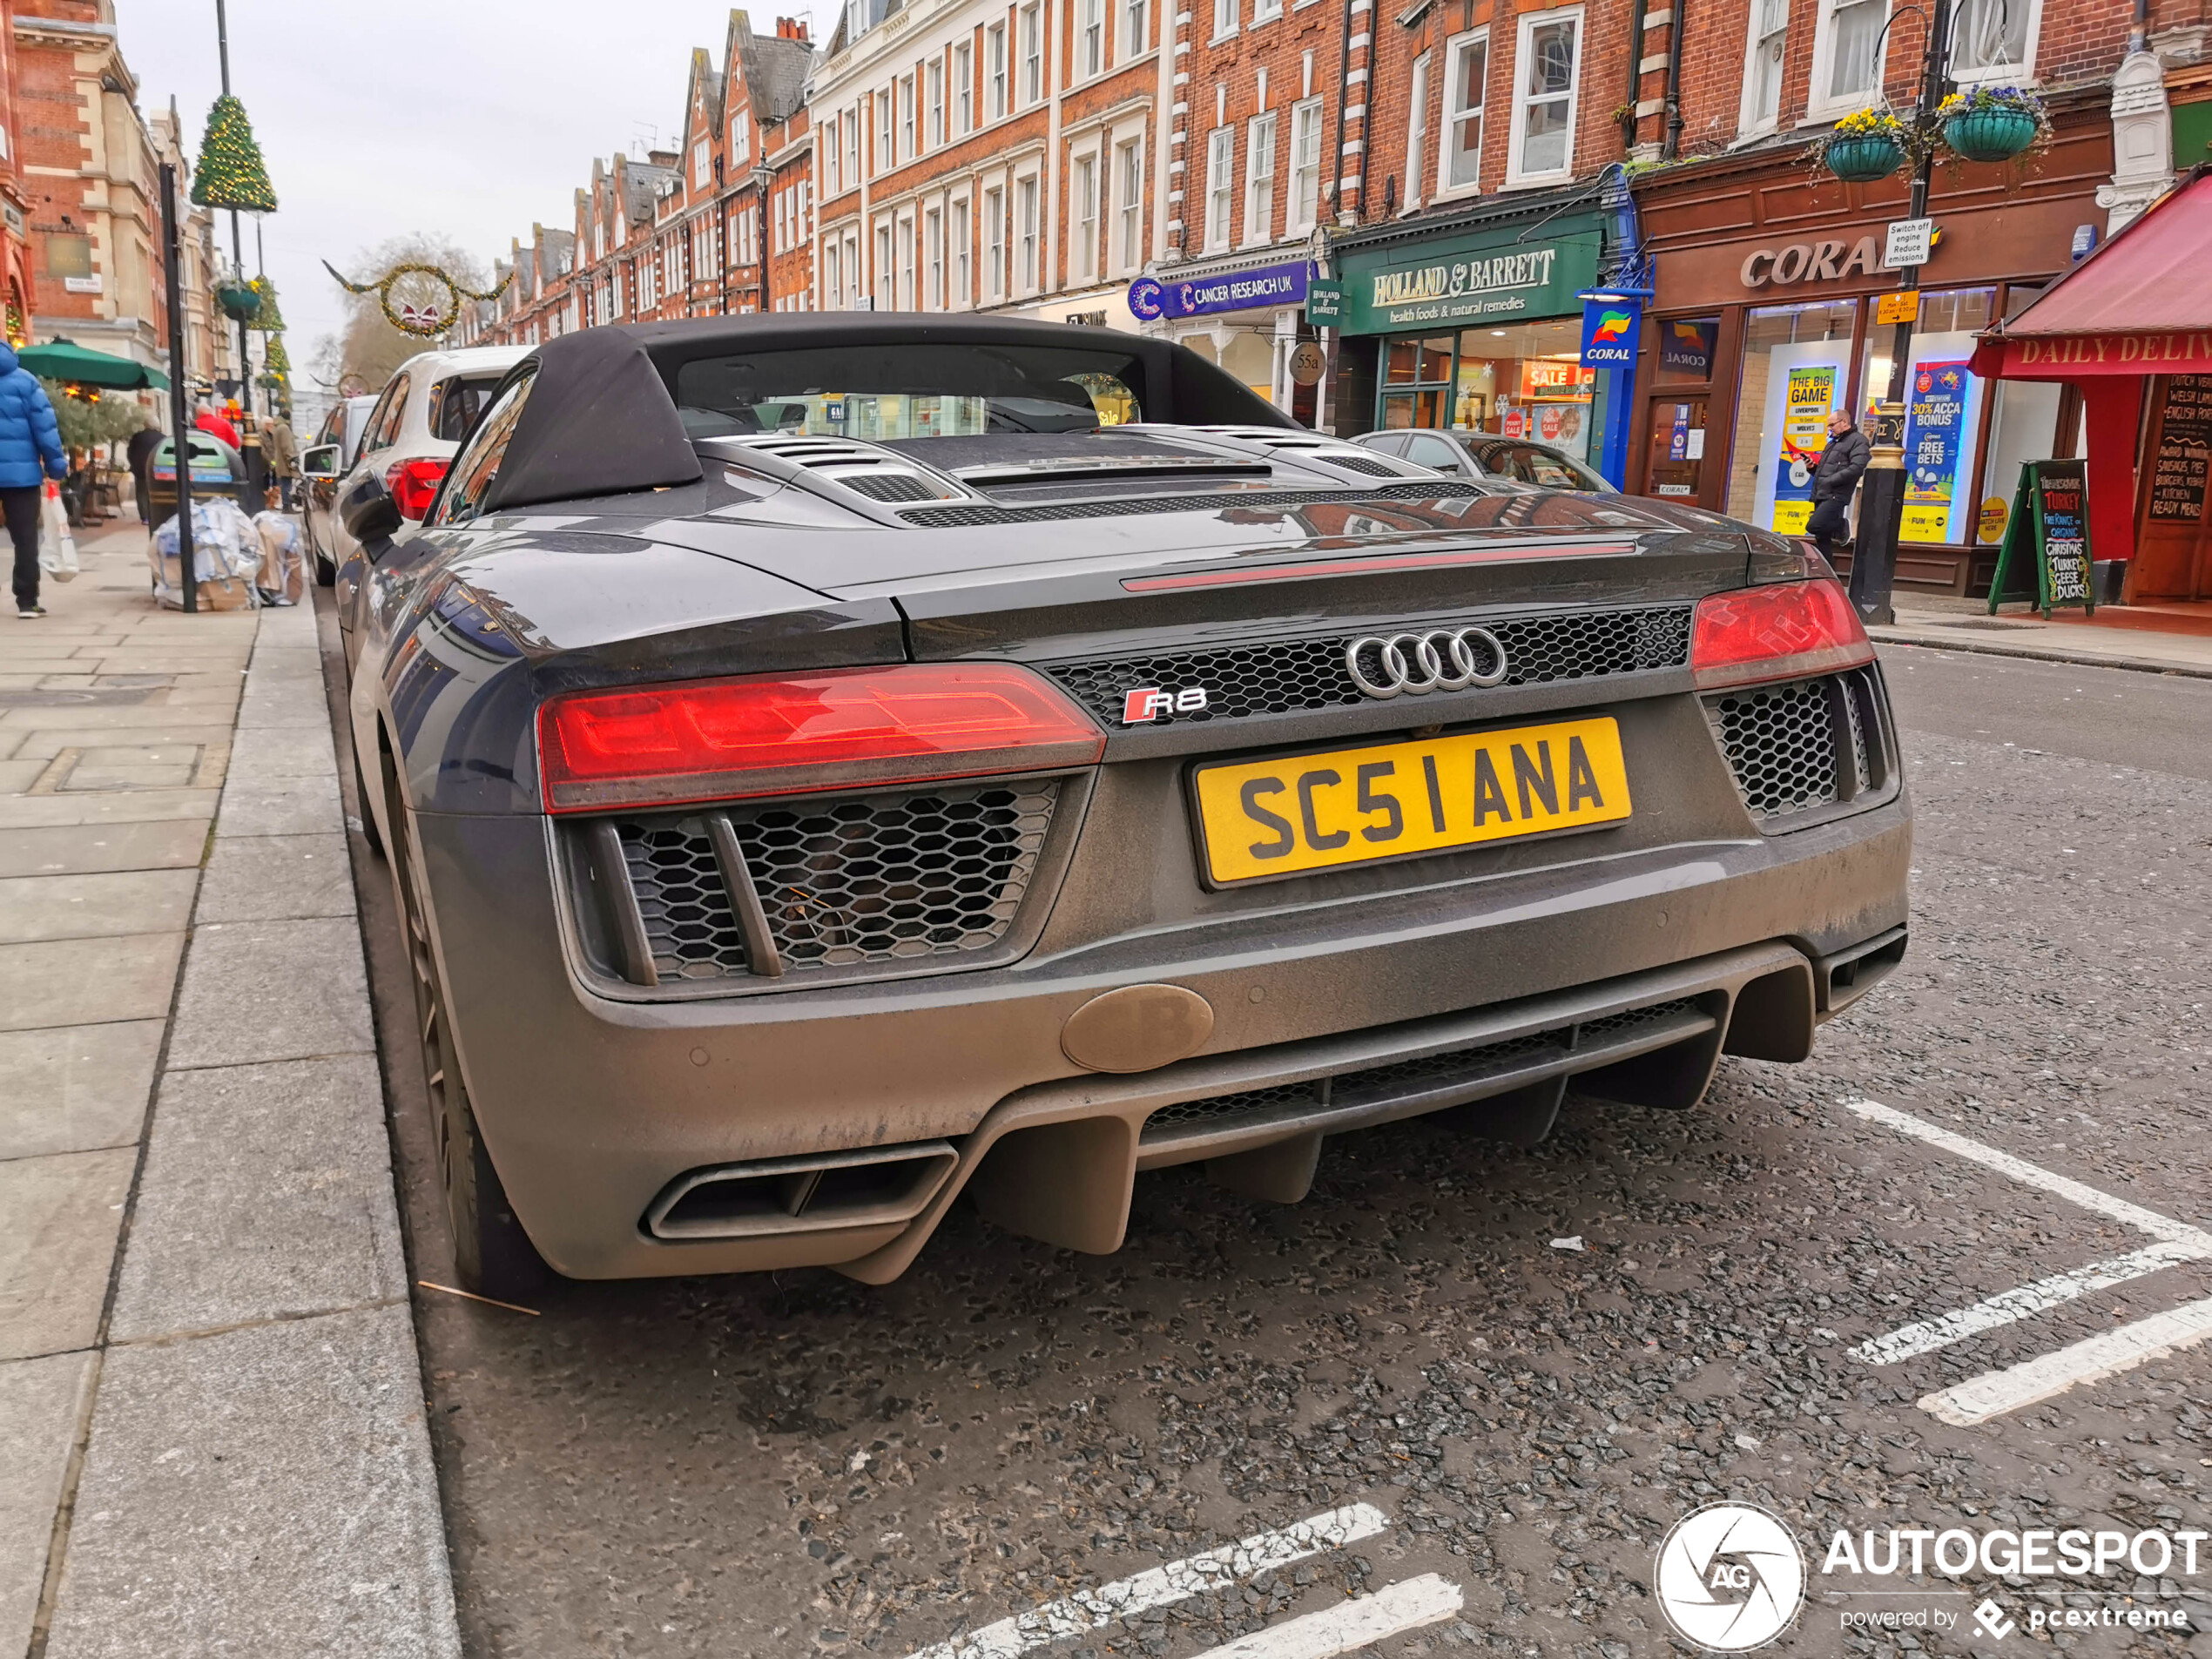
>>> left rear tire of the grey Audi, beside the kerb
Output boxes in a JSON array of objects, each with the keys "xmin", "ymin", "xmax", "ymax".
[{"xmin": 385, "ymin": 765, "xmax": 553, "ymax": 1301}]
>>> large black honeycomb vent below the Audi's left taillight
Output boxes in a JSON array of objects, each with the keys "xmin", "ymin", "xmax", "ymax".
[{"xmin": 615, "ymin": 779, "xmax": 1060, "ymax": 982}]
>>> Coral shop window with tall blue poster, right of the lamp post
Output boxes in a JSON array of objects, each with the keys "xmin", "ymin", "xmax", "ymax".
[{"xmin": 1858, "ymin": 287, "xmax": 1998, "ymax": 544}]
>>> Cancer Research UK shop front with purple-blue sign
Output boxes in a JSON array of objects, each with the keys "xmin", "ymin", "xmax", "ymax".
[{"xmin": 1126, "ymin": 246, "xmax": 1318, "ymax": 427}]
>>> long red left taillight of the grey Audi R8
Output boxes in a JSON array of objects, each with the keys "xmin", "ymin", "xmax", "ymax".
[{"xmin": 537, "ymin": 664, "xmax": 1106, "ymax": 812}]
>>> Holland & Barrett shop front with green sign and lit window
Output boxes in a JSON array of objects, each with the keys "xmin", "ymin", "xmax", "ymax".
[{"xmin": 1334, "ymin": 201, "xmax": 1628, "ymax": 464}]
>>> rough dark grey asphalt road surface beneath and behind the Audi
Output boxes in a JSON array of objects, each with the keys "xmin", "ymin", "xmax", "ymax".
[{"xmin": 332, "ymin": 648, "xmax": 2212, "ymax": 1659}]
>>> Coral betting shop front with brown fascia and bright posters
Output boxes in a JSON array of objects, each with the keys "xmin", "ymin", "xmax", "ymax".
[{"xmin": 1626, "ymin": 111, "xmax": 2113, "ymax": 595}]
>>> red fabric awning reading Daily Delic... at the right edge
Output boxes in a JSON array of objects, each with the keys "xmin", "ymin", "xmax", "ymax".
[{"xmin": 1973, "ymin": 166, "xmax": 2212, "ymax": 381}]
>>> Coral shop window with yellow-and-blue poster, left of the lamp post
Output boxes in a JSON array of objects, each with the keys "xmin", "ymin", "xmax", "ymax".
[{"xmin": 1728, "ymin": 299, "xmax": 1858, "ymax": 536}]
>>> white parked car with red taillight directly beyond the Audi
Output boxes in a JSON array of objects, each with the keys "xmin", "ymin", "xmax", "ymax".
[{"xmin": 300, "ymin": 345, "xmax": 524, "ymax": 615}]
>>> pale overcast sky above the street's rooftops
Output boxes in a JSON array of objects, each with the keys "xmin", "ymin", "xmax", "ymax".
[{"xmin": 115, "ymin": 0, "xmax": 836, "ymax": 392}]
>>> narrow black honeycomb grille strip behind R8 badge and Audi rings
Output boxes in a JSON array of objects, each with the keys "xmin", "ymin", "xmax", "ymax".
[{"xmin": 1046, "ymin": 604, "xmax": 1690, "ymax": 730}]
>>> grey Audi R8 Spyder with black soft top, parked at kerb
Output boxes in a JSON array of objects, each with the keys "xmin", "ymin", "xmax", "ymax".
[{"xmin": 343, "ymin": 314, "xmax": 1912, "ymax": 1294}]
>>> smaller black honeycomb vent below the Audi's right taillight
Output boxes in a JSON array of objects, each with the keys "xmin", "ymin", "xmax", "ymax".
[{"xmin": 1705, "ymin": 668, "xmax": 1889, "ymax": 827}]
